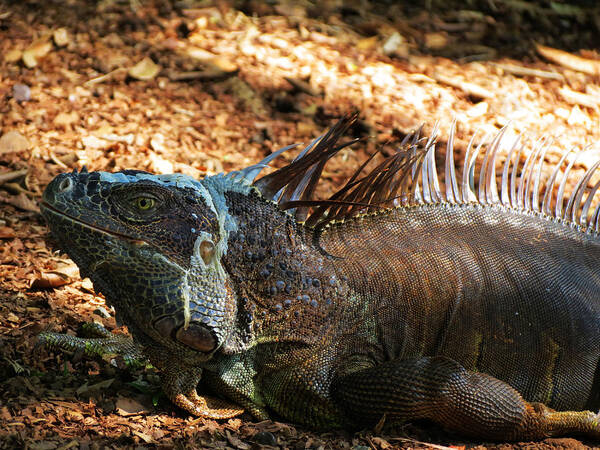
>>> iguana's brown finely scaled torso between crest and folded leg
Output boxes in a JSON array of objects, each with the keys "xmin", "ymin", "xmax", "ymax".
[{"xmin": 320, "ymin": 204, "xmax": 600, "ymax": 410}]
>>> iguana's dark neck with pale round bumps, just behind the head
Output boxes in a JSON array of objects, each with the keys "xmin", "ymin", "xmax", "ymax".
[{"xmin": 222, "ymin": 190, "xmax": 349, "ymax": 350}]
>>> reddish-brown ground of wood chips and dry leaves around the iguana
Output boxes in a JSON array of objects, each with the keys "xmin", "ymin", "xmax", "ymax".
[{"xmin": 0, "ymin": 0, "xmax": 600, "ymax": 450}]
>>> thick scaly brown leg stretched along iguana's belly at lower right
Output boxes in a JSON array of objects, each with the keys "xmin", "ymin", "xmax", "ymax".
[{"xmin": 332, "ymin": 357, "xmax": 600, "ymax": 440}]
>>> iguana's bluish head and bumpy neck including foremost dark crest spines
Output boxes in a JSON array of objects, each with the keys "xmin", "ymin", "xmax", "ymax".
[{"xmin": 41, "ymin": 117, "xmax": 364, "ymax": 361}]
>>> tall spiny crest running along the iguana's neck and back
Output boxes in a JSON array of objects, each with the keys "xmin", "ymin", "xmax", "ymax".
[{"xmin": 245, "ymin": 113, "xmax": 600, "ymax": 234}]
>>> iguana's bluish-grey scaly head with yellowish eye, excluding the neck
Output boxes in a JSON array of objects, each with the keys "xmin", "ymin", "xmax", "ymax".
[{"xmin": 42, "ymin": 171, "xmax": 249, "ymax": 362}]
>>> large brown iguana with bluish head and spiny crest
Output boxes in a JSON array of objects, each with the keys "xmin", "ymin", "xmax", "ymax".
[{"xmin": 41, "ymin": 114, "xmax": 600, "ymax": 440}]
